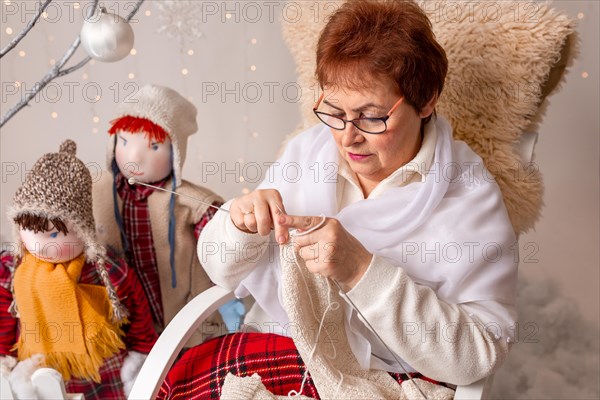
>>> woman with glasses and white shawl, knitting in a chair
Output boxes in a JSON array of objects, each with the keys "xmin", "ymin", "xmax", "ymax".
[{"xmin": 157, "ymin": 1, "xmax": 518, "ymax": 397}]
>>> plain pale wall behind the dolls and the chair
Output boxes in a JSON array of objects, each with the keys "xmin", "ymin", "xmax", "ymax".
[{"xmin": 0, "ymin": 0, "xmax": 600, "ymax": 332}]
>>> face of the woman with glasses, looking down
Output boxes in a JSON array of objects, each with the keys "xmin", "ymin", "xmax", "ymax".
[{"xmin": 319, "ymin": 84, "xmax": 433, "ymax": 195}]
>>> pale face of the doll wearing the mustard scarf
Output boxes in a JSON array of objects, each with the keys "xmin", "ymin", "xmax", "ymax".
[{"xmin": 20, "ymin": 223, "xmax": 85, "ymax": 264}]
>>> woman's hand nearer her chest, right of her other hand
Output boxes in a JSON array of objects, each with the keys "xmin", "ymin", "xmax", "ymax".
[{"xmin": 278, "ymin": 215, "xmax": 373, "ymax": 291}]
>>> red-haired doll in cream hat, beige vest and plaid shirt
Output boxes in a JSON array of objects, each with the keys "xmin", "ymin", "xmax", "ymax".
[{"xmin": 94, "ymin": 85, "xmax": 231, "ymax": 344}]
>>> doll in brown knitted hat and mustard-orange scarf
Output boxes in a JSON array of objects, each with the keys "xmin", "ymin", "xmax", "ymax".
[{"xmin": 0, "ymin": 140, "xmax": 157, "ymax": 399}]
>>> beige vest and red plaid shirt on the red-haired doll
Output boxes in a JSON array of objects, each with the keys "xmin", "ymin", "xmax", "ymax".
[{"xmin": 93, "ymin": 172, "xmax": 223, "ymax": 345}]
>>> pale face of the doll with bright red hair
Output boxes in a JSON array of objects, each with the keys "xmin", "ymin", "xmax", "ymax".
[{"xmin": 115, "ymin": 131, "xmax": 173, "ymax": 183}]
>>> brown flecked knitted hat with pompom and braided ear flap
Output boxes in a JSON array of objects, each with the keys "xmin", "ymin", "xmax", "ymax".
[{"xmin": 8, "ymin": 140, "xmax": 127, "ymax": 322}]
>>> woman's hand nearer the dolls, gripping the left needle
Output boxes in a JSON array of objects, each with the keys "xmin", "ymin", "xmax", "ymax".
[{"xmin": 229, "ymin": 189, "xmax": 288, "ymax": 244}]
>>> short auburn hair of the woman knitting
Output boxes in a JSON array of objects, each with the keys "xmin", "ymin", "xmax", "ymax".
[{"xmin": 316, "ymin": 0, "xmax": 448, "ymax": 122}]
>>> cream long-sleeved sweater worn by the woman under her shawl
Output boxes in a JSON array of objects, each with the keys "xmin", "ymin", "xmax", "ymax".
[{"xmin": 198, "ymin": 122, "xmax": 516, "ymax": 385}]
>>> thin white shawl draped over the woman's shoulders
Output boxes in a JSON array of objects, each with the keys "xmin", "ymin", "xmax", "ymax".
[{"xmin": 236, "ymin": 117, "xmax": 518, "ymax": 368}]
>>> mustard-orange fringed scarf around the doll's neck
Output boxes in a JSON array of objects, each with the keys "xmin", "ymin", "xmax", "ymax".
[{"xmin": 14, "ymin": 253, "xmax": 125, "ymax": 382}]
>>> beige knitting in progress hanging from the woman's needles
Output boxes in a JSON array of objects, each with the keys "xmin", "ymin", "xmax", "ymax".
[{"xmin": 221, "ymin": 244, "xmax": 454, "ymax": 399}]
